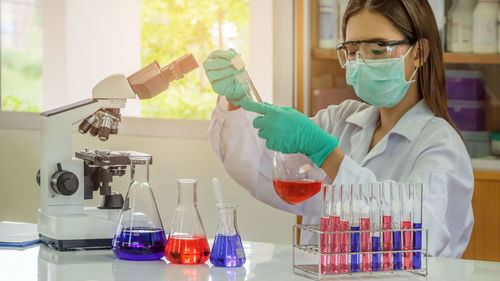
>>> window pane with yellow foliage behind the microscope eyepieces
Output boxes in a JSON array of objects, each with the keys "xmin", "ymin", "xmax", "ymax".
[{"xmin": 141, "ymin": 0, "xmax": 249, "ymax": 119}]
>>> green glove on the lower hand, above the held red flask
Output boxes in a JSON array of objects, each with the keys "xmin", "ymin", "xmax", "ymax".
[{"xmin": 241, "ymin": 100, "xmax": 339, "ymax": 167}]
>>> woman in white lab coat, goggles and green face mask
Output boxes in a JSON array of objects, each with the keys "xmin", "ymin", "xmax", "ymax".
[{"xmin": 204, "ymin": 0, "xmax": 474, "ymax": 257}]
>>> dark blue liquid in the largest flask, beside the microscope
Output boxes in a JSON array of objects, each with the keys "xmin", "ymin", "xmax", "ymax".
[{"xmin": 113, "ymin": 227, "xmax": 167, "ymax": 261}]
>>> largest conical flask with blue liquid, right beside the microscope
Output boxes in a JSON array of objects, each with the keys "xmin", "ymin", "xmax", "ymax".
[{"xmin": 113, "ymin": 156, "xmax": 166, "ymax": 260}]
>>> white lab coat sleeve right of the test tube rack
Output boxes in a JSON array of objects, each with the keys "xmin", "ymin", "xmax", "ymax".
[{"xmin": 408, "ymin": 134, "xmax": 474, "ymax": 258}]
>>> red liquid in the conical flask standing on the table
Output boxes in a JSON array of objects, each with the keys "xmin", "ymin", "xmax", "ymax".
[{"xmin": 165, "ymin": 235, "xmax": 210, "ymax": 264}]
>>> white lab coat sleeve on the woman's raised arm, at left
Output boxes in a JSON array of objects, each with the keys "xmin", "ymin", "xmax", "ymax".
[{"xmin": 209, "ymin": 97, "xmax": 304, "ymax": 215}]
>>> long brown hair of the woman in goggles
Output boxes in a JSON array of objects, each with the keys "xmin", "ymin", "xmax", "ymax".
[{"xmin": 342, "ymin": 0, "xmax": 461, "ymax": 136}]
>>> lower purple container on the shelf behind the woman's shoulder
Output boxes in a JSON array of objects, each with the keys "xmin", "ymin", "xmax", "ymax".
[{"xmin": 448, "ymin": 100, "xmax": 485, "ymax": 131}]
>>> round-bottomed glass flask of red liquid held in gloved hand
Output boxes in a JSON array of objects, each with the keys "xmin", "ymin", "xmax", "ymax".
[{"xmin": 273, "ymin": 151, "xmax": 325, "ymax": 205}]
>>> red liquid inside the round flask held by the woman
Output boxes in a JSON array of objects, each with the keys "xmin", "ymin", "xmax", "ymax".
[{"xmin": 273, "ymin": 180, "xmax": 321, "ymax": 205}]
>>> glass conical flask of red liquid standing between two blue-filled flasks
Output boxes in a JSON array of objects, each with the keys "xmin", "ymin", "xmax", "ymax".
[{"xmin": 165, "ymin": 179, "xmax": 210, "ymax": 264}]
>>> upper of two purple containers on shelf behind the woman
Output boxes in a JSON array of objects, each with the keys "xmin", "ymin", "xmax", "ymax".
[{"xmin": 446, "ymin": 70, "xmax": 485, "ymax": 101}]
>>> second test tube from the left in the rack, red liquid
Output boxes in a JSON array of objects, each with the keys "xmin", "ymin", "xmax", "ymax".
[{"xmin": 330, "ymin": 185, "xmax": 342, "ymax": 273}]
